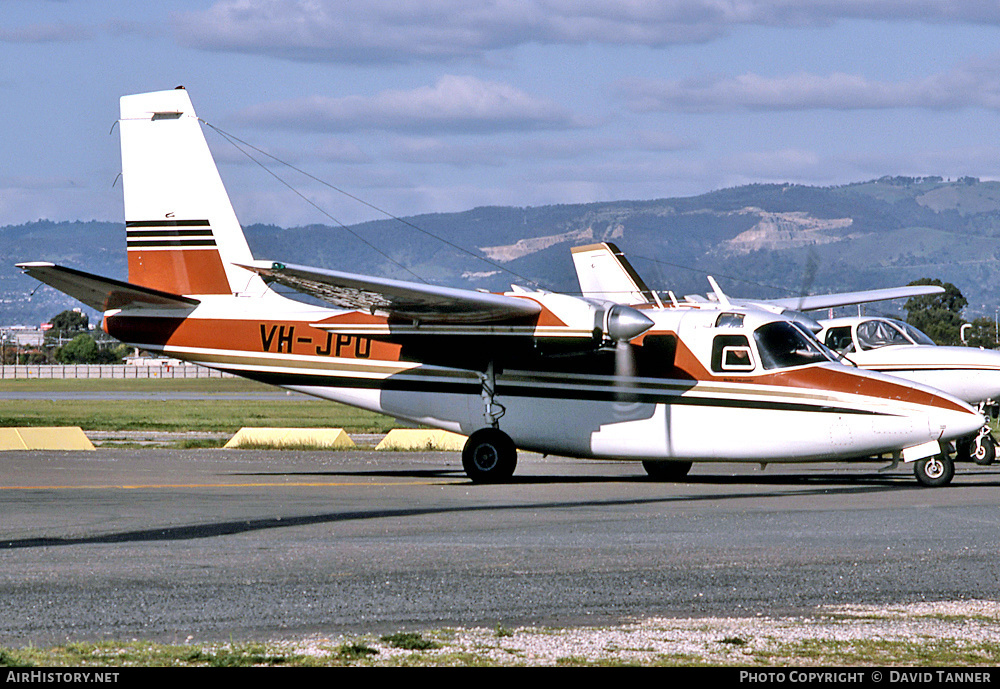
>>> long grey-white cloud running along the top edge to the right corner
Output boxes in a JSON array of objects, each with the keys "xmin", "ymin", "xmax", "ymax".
[{"xmin": 174, "ymin": 0, "xmax": 1000, "ymax": 63}]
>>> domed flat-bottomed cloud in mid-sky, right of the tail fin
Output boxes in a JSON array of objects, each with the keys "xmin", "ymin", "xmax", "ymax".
[{"xmin": 237, "ymin": 75, "xmax": 574, "ymax": 132}]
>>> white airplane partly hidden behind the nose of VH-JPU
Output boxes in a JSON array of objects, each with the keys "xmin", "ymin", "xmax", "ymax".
[{"xmin": 816, "ymin": 316, "xmax": 1000, "ymax": 466}]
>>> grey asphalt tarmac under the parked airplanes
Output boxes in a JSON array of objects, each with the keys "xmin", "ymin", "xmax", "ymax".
[{"xmin": 0, "ymin": 448, "xmax": 1000, "ymax": 646}]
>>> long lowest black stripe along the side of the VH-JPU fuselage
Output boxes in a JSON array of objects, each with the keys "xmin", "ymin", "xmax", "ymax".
[{"xmin": 222, "ymin": 368, "xmax": 895, "ymax": 416}]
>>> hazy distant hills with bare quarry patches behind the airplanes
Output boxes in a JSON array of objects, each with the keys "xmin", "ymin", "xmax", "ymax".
[{"xmin": 0, "ymin": 177, "xmax": 1000, "ymax": 324}]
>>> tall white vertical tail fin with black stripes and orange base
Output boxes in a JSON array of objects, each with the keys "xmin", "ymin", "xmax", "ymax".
[{"xmin": 120, "ymin": 88, "xmax": 266, "ymax": 295}]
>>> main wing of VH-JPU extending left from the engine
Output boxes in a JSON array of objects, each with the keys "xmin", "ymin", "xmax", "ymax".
[{"xmin": 241, "ymin": 262, "xmax": 542, "ymax": 324}]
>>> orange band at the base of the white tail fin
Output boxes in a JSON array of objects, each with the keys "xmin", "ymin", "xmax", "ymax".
[{"xmin": 128, "ymin": 248, "xmax": 232, "ymax": 294}]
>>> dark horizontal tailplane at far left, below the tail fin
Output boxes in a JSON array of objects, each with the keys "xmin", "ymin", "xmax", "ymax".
[{"xmin": 17, "ymin": 262, "xmax": 201, "ymax": 312}]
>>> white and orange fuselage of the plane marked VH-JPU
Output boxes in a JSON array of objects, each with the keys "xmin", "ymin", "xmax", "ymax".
[{"xmin": 107, "ymin": 295, "xmax": 982, "ymax": 462}]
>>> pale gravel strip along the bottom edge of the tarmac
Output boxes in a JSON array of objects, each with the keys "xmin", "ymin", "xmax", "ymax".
[{"xmin": 284, "ymin": 601, "xmax": 1000, "ymax": 666}]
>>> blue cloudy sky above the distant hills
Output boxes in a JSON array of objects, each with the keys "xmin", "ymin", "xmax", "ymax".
[{"xmin": 0, "ymin": 0, "xmax": 1000, "ymax": 226}]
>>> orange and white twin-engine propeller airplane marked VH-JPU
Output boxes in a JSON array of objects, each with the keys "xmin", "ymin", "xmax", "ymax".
[{"xmin": 19, "ymin": 90, "xmax": 983, "ymax": 485}]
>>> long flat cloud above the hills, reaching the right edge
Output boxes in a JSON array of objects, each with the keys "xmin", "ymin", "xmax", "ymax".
[{"xmin": 620, "ymin": 58, "xmax": 1000, "ymax": 112}]
